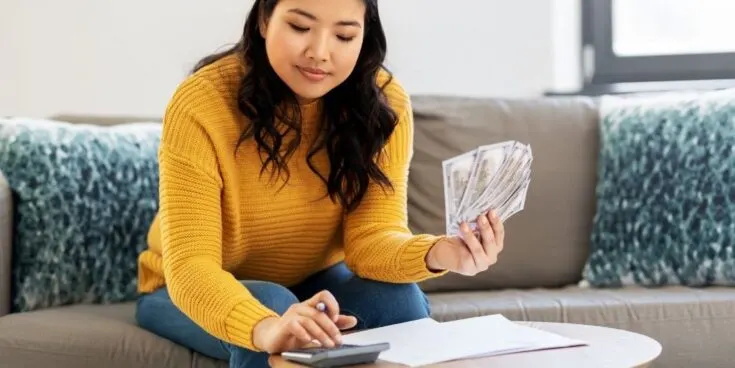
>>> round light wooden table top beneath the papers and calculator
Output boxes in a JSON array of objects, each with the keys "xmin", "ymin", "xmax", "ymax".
[{"xmin": 269, "ymin": 322, "xmax": 661, "ymax": 368}]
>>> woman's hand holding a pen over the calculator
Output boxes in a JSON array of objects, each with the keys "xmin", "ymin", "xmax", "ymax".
[{"xmin": 253, "ymin": 290, "xmax": 357, "ymax": 354}]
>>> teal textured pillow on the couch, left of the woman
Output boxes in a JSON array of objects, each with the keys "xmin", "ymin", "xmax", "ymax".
[{"xmin": 0, "ymin": 118, "xmax": 160, "ymax": 312}]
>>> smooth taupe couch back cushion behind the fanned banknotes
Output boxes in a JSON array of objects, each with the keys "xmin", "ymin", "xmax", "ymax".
[{"xmin": 408, "ymin": 96, "xmax": 598, "ymax": 291}]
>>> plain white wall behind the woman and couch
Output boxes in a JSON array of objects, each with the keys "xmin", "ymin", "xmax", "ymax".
[{"xmin": 0, "ymin": 0, "xmax": 579, "ymax": 116}]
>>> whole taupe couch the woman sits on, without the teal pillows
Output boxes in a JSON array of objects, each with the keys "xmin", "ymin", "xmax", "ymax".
[{"xmin": 0, "ymin": 96, "xmax": 735, "ymax": 368}]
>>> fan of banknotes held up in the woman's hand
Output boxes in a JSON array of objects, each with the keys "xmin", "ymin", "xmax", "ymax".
[{"xmin": 442, "ymin": 141, "xmax": 533, "ymax": 235}]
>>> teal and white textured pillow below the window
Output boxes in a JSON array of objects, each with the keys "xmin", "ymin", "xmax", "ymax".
[{"xmin": 583, "ymin": 90, "xmax": 735, "ymax": 287}]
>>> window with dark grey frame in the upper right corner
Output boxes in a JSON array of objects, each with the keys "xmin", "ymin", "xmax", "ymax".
[{"xmin": 581, "ymin": 0, "xmax": 735, "ymax": 88}]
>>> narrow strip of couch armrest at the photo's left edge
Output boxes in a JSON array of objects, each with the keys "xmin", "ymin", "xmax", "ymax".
[{"xmin": 0, "ymin": 171, "xmax": 13, "ymax": 317}]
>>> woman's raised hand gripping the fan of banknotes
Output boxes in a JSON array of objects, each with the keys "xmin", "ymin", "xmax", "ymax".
[{"xmin": 426, "ymin": 211, "xmax": 505, "ymax": 276}]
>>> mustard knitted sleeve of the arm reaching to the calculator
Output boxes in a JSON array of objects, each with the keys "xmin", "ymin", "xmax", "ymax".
[{"xmin": 159, "ymin": 79, "xmax": 277, "ymax": 350}]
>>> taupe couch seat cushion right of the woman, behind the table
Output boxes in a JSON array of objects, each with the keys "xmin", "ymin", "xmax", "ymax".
[{"xmin": 429, "ymin": 286, "xmax": 735, "ymax": 368}]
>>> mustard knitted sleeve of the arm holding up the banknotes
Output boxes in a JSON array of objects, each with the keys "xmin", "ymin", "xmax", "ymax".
[{"xmin": 344, "ymin": 77, "xmax": 446, "ymax": 283}]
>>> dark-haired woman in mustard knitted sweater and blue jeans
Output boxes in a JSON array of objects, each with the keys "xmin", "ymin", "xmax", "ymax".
[{"xmin": 137, "ymin": 0, "xmax": 503, "ymax": 367}]
